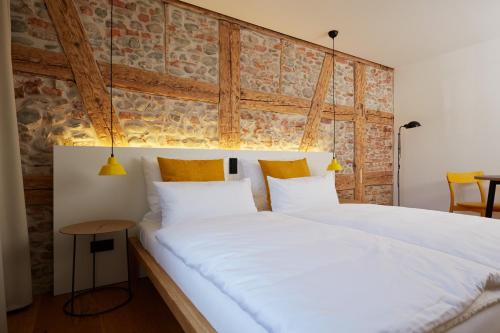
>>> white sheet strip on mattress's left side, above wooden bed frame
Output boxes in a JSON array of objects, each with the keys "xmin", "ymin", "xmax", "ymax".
[{"xmin": 139, "ymin": 214, "xmax": 266, "ymax": 333}]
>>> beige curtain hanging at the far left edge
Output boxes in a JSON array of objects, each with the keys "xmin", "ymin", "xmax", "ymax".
[{"xmin": 0, "ymin": 0, "xmax": 32, "ymax": 310}]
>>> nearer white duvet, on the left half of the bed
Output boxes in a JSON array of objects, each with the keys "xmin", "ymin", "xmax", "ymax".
[{"xmin": 156, "ymin": 212, "xmax": 499, "ymax": 333}]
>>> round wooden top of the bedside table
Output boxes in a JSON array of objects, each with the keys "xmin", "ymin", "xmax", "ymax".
[{"xmin": 59, "ymin": 220, "xmax": 135, "ymax": 235}]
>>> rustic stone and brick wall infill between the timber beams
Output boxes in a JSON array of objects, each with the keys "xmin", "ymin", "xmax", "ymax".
[{"xmin": 6, "ymin": 0, "xmax": 393, "ymax": 293}]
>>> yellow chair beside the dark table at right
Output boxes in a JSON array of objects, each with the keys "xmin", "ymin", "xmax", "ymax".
[{"xmin": 446, "ymin": 171, "xmax": 500, "ymax": 216}]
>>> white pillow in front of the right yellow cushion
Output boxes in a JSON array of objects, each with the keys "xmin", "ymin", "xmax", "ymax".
[{"xmin": 267, "ymin": 172, "xmax": 339, "ymax": 213}]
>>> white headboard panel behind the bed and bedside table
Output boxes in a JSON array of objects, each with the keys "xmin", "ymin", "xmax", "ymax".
[{"xmin": 54, "ymin": 146, "xmax": 331, "ymax": 295}]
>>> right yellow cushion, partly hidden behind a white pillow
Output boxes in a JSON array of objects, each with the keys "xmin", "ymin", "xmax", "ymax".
[{"xmin": 259, "ymin": 158, "xmax": 311, "ymax": 207}]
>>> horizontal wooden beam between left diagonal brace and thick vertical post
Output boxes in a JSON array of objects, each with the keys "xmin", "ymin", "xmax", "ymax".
[{"xmin": 99, "ymin": 62, "xmax": 219, "ymax": 103}]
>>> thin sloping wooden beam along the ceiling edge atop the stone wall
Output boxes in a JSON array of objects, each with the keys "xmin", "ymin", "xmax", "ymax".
[{"xmin": 163, "ymin": 0, "xmax": 394, "ymax": 71}]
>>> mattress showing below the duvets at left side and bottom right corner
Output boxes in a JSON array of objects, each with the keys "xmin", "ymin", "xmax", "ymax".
[{"xmin": 139, "ymin": 215, "xmax": 500, "ymax": 333}]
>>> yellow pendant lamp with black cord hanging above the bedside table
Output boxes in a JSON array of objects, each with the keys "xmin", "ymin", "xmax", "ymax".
[{"xmin": 99, "ymin": 0, "xmax": 127, "ymax": 176}]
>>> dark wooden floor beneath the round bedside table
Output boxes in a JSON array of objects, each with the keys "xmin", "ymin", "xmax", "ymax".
[{"xmin": 8, "ymin": 279, "xmax": 182, "ymax": 333}]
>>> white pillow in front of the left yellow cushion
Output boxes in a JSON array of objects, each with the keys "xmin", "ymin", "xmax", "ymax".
[{"xmin": 154, "ymin": 178, "xmax": 257, "ymax": 227}]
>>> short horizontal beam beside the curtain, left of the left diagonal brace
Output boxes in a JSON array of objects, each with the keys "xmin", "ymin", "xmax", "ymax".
[{"xmin": 11, "ymin": 43, "xmax": 74, "ymax": 80}]
